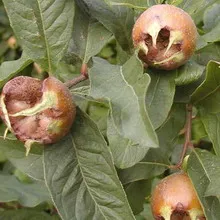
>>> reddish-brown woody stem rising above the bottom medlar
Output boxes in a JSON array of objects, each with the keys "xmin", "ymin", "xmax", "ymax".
[{"xmin": 171, "ymin": 104, "xmax": 192, "ymax": 169}]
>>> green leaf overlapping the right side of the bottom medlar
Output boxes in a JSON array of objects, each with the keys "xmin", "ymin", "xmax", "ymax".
[{"xmin": 187, "ymin": 149, "xmax": 220, "ymax": 220}]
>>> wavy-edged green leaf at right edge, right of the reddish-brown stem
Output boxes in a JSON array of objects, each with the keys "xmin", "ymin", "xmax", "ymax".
[{"xmin": 191, "ymin": 61, "xmax": 220, "ymax": 155}]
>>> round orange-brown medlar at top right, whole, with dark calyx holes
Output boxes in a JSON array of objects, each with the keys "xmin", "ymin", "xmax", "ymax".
[{"xmin": 132, "ymin": 5, "xmax": 197, "ymax": 70}]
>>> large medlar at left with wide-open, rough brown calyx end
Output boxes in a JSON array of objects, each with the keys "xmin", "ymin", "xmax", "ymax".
[{"xmin": 0, "ymin": 76, "xmax": 76, "ymax": 153}]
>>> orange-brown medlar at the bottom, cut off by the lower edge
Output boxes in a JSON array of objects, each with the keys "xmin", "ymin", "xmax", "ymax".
[{"xmin": 151, "ymin": 172, "xmax": 205, "ymax": 220}]
